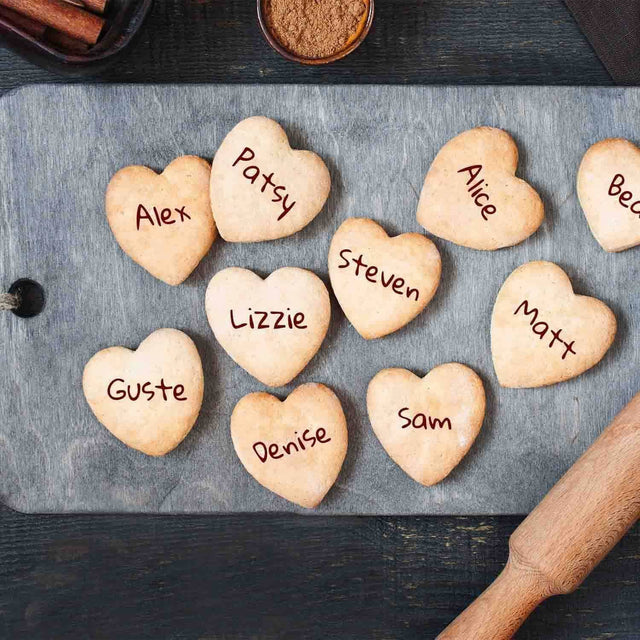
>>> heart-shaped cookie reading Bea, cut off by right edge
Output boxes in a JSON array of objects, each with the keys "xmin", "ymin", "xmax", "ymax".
[{"xmin": 578, "ymin": 138, "xmax": 640, "ymax": 251}]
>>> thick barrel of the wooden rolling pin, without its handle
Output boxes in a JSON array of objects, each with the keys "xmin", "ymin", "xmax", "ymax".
[{"xmin": 510, "ymin": 394, "xmax": 640, "ymax": 594}]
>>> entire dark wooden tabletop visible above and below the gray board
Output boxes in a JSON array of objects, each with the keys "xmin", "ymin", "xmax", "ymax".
[{"xmin": 0, "ymin": 0, "xmax": 640, "ymax": 640}]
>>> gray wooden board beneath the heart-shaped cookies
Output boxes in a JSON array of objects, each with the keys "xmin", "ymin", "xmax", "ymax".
[{"xmin": 0, "ymin": 85, "xmax": 640, "ymax": 514}]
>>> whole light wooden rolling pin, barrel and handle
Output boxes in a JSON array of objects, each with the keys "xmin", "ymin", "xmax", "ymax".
[{"xmin": 437, "ymin": 393, "xmax": 640, "ymax": 640}]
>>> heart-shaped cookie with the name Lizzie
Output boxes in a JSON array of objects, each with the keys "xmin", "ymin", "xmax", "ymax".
[{"xmin": 205, "ymin": 267, "xmax": 331, "ymax": 387}]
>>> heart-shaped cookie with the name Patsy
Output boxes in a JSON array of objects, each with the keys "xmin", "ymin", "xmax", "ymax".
[{"xmin": 211, "ymin": 116, "xmax": 331, "ymax": 242}]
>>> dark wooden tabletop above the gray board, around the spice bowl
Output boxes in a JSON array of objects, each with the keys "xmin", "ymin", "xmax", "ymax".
[{"xmin": 0, "ymin": 0, "xmax": 611, "ymax": 91}]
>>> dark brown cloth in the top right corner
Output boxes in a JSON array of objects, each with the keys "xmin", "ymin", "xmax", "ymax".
[{"xmin": 565, "ymin": 0, "xmax": 640, "ymax": 84}]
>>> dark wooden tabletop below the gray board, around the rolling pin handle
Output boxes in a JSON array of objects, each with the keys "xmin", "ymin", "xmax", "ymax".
[{"xmin": 0, "ymin": 512, "xmax": 640, "ymax": 640}]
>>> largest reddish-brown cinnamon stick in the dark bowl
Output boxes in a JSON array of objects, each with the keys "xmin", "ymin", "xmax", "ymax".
[{"xmin": 0, "ymin": 0, "xmax": 105, "ymax": 44}]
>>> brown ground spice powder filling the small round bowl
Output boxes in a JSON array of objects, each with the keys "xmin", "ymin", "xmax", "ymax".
[{"xmin": 264, "ymin": 0, "xmax": 367, "ymax": 58}]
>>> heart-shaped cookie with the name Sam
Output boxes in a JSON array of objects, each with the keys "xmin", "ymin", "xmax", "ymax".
[{"xmin": 367, "ymin": 362, "xmax": 485, "ymax": 486}]
